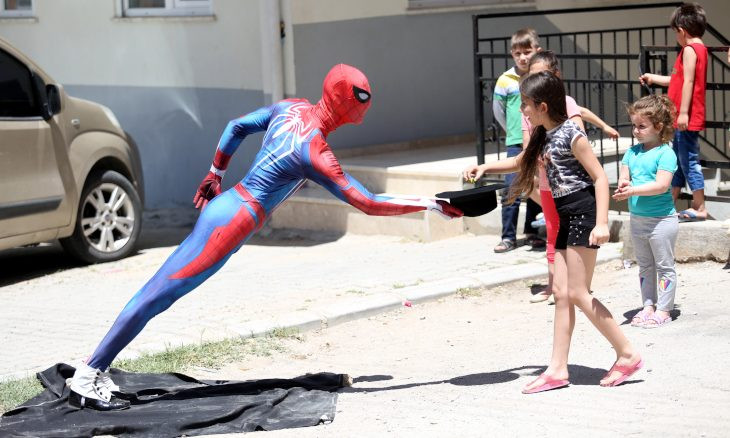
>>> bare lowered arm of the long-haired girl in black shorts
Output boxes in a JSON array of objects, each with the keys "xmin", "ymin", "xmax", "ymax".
[{"xmin": 572, "ymin": 136, "xmax": 609, "ymax": 245}]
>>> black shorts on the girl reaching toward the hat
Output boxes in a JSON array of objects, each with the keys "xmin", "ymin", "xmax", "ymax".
[{"xmin": 555, "ymin": 186, "xmax": 600, "ymax": 250}]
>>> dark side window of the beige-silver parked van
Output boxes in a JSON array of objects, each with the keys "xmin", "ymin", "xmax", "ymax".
[{"xmin": 0, "ymin": 50, "xmax": 41, "ymax": 117}]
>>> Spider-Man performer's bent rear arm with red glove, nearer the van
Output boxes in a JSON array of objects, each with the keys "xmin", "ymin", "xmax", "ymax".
[{"xmin": 193, "ymin": 107, "xmax": 272, "ymax": 208}]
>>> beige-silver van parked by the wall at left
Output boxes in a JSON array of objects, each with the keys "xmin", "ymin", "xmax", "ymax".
[{"xmin": 0, "ymin": 38, "xmax": 144, "ymax": 263}]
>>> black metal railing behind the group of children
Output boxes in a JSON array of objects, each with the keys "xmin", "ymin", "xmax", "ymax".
[{"xmin": 473, "ymin": 3, "xmax": 730, "ymax": 204}]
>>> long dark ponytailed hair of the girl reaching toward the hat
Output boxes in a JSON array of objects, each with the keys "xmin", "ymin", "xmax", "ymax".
[{"xmin": 508, "ymin": 71, "xmax": 568, "ymax": 202}]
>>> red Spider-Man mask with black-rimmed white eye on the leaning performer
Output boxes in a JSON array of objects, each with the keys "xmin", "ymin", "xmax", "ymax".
[{"xmin": 319, "ymin": 64, "xmax": 370, "ymax": 129}]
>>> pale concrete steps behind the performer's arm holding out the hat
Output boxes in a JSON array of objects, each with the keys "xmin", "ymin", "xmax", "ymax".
[{"xmin": 268, "ymin": 138, "xmax": 631, "ymax": 241}]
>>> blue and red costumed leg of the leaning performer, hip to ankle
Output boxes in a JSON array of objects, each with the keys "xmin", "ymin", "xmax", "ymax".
[{"xmin": 88, "ymin": 189, "xmax": 260, "ymax": 370}]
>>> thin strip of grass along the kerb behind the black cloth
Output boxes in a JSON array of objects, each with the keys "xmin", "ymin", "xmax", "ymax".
[{"xmin": 0, "ymin": 328, "xmax": 301, "ymax": 414}]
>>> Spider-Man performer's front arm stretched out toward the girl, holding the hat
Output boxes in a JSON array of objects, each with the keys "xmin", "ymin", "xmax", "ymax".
[{"xmin": 302, "ymin": 135, "xmax": 463, "ymax": 218}]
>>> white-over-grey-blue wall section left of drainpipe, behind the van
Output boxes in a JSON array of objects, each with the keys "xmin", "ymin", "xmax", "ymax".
[{"xmin": 0, "ymin": 0, "xmax": 266, "ymax": 208}]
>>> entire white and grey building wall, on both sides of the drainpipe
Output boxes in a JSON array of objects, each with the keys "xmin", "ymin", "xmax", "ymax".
[{"xmin": 0, "ymin": 0, "xmax": 730, "ymax": 208}]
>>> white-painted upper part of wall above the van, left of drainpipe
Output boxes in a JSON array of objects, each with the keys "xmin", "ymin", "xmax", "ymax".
[{"xmin": 0, "ymin": 0, "xmax": 263, "ymax": 90}]
